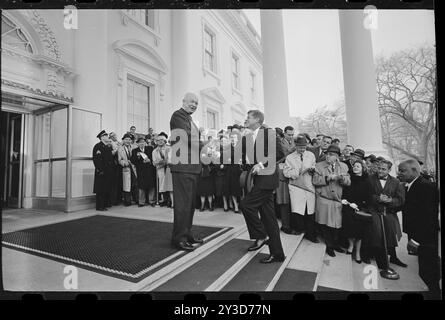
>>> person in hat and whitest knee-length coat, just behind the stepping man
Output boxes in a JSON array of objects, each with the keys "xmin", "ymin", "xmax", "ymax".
[{"xmin": 282, "ymin": 135, "xmax": 318, "ymax": 242}]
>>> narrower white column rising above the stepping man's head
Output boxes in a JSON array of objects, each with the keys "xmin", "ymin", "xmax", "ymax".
[{"xmin": 261, "ymin": 10, "xmax": 290, "ymax": 128}]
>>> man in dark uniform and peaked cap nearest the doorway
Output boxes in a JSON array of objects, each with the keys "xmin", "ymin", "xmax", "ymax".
[{"xmin": 93, "ymin": 130, "xmax": 113, "ymax": 211}]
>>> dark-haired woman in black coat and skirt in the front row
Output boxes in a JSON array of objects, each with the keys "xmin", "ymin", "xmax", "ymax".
[{"xmin": 342, "ymin": 160, "xmax": 371, "ymax": 263}]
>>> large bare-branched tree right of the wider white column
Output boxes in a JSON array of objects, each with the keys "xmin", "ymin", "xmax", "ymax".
[{"xmin": 376, "ymin": 47, "xmax": 437, "ymax": 168}]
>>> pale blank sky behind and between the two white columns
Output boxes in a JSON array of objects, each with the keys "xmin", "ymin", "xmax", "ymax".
[{"xmin": 243, "ymin": 10, "xmax": 435, "ymax": 117}]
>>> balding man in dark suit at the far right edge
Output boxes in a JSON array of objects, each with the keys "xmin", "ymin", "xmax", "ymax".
[{"xmin": 398, "ymin": 159, "xmax": 440, "ymax": 293}]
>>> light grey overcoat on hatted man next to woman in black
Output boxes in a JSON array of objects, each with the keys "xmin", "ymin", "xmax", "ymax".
[{"xmin": 312, "ymin": 160, "xmax": 351, "ymax": 229}]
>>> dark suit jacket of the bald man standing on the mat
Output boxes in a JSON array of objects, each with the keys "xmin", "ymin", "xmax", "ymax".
[{"xmin": 170, "ymin": 108, "xmax": 203, "ymax": 174}]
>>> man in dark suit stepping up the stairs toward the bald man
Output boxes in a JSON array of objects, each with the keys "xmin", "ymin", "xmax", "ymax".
[{"xmin": 240, "ymin": 110, "xmax": 285, "ymax": 263}]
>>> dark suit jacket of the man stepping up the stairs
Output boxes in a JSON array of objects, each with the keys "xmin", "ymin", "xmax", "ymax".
[{"xmin": 243, "ymin": 126, "xmax": 284, "ymax": 190}]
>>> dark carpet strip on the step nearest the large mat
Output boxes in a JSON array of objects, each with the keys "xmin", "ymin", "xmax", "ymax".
[{"xmin": 153, "ymin": 239, "xmax": 252, "ymax": 291}]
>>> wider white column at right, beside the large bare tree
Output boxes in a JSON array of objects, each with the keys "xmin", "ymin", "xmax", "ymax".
[{"xmin": 339, "ymin": 10, "xmax": 386, "ymax": 157}]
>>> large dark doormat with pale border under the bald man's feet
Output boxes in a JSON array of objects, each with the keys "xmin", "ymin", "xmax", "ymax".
[{"xmin": 2, "ymin": 215, "xmax": 230, "ymax": 282}]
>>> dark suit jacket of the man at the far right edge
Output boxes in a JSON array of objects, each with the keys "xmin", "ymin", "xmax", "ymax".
[{"xmin": 402, "ymin": 176, "xmax": 439, "ymax": 245}]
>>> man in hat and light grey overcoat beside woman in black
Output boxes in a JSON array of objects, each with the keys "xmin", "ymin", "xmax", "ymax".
[{"xmin": 312, "ymin": 145, "xmax": 351, "ymax": 257}]
